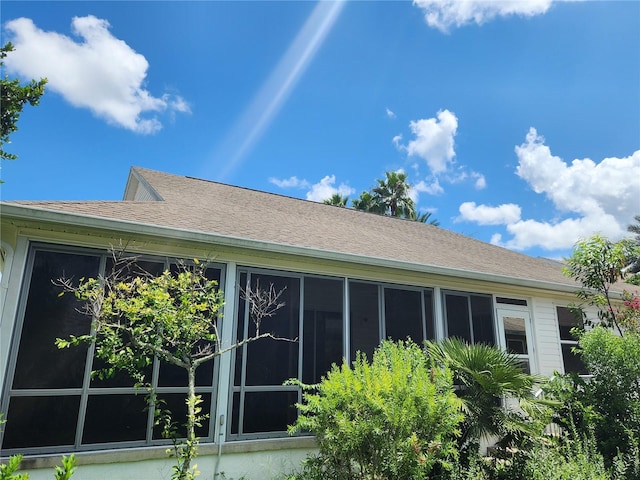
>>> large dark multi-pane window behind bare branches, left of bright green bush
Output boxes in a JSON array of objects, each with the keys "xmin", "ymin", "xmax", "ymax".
[{"xmin": 230, "ymin": 269, "xmax": 344, "ymax": 438}]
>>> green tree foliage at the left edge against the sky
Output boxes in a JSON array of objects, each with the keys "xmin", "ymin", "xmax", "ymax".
[{"xmin": 0, "ymin": 43, "xmax": 47, "ymax": 166}]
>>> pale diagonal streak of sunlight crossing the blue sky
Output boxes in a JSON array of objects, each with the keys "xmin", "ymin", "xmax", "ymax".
[{"xmin": 206, "ymin": 0, "xmax": 345, "ymax": 180}]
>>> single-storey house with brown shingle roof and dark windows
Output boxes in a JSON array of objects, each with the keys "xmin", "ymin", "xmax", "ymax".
[{"xmin": 0, "ymin": 168, "xmax": 592, "ymax": 479}]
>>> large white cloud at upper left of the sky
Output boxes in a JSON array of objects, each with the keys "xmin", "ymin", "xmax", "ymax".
[{"xmin": 5, "ymin": 15, "xmax": 190, "ymax": 134}]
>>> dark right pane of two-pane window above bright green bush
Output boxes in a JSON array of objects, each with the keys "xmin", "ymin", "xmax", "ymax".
[{"xmin": 384, "ymin": 288, "xmax": 424, "ymax": 344}]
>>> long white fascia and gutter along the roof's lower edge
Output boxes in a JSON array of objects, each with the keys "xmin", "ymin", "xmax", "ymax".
[{"xmin": 0, "ymin": 202, "xmax": 578, "ymax": 293}]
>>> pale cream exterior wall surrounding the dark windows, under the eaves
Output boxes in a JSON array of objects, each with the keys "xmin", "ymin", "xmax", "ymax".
[{"xmin": 0, "ymin": 216, "xmax": 573, "ymax": 480}]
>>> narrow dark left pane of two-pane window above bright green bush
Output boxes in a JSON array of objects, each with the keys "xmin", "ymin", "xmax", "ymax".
[{"xmin": 349, "ymin": 282, "xmax": 380, "ymax": 361}]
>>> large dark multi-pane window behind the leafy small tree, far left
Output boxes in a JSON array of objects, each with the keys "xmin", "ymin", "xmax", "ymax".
[{"xmin": 1, "ymin": 245, "xmax": 222, "ymax": 453}]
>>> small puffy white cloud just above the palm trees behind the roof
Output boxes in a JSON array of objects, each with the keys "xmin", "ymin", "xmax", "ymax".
[{"xmin": 402, "ymin": 110, "xmax": 458, "ymax": 175}]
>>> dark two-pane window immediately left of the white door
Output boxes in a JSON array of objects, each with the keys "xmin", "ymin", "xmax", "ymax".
[{"xmin": 444, "ymin": 292, "xmax": 496, "ymax": 345}]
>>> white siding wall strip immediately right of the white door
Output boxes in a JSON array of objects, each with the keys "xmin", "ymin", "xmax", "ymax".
[{"xmin": 532, "ymin": 298, "xmax": 564, "ymax": 376}]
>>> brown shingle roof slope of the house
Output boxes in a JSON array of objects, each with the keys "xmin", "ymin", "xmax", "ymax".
[{"xmin": 3, "ymin": 168, "xmax": 574, "ymax": 286}]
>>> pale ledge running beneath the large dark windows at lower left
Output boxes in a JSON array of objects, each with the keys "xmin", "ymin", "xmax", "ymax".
[{"xmin": 0, "ymin": 437, "xmax": 317, "ymax": 470}]
